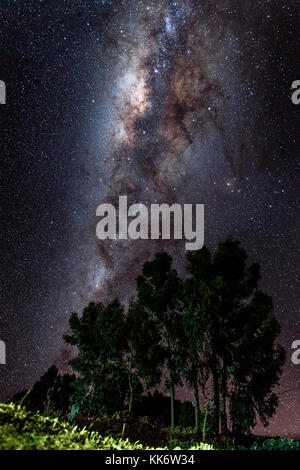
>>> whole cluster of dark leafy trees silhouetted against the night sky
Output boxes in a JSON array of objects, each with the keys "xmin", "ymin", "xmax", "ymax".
[{"xmin": 64, "ymin": 237, "xmax": 285, "ymax": 434}]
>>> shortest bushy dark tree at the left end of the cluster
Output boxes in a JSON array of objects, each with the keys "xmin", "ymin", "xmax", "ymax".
[{"xmin": 64, "ymin": 299, "xmax": 127, "ymax": 416}]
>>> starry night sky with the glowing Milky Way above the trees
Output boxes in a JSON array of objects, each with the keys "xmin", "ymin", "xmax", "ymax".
[{"xmin": 0, "ymin": 0, "xmax": 300, "ymax": 438}]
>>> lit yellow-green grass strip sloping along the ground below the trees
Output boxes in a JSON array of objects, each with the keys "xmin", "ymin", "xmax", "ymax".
[{"xmin": 0, "ymin": 403, "xmax": 300, "ymax": 450}]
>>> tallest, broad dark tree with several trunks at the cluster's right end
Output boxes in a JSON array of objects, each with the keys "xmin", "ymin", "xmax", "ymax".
[{"xmin": 187, "ymin": 237, "xmax": 284, "ymax": 434}]
